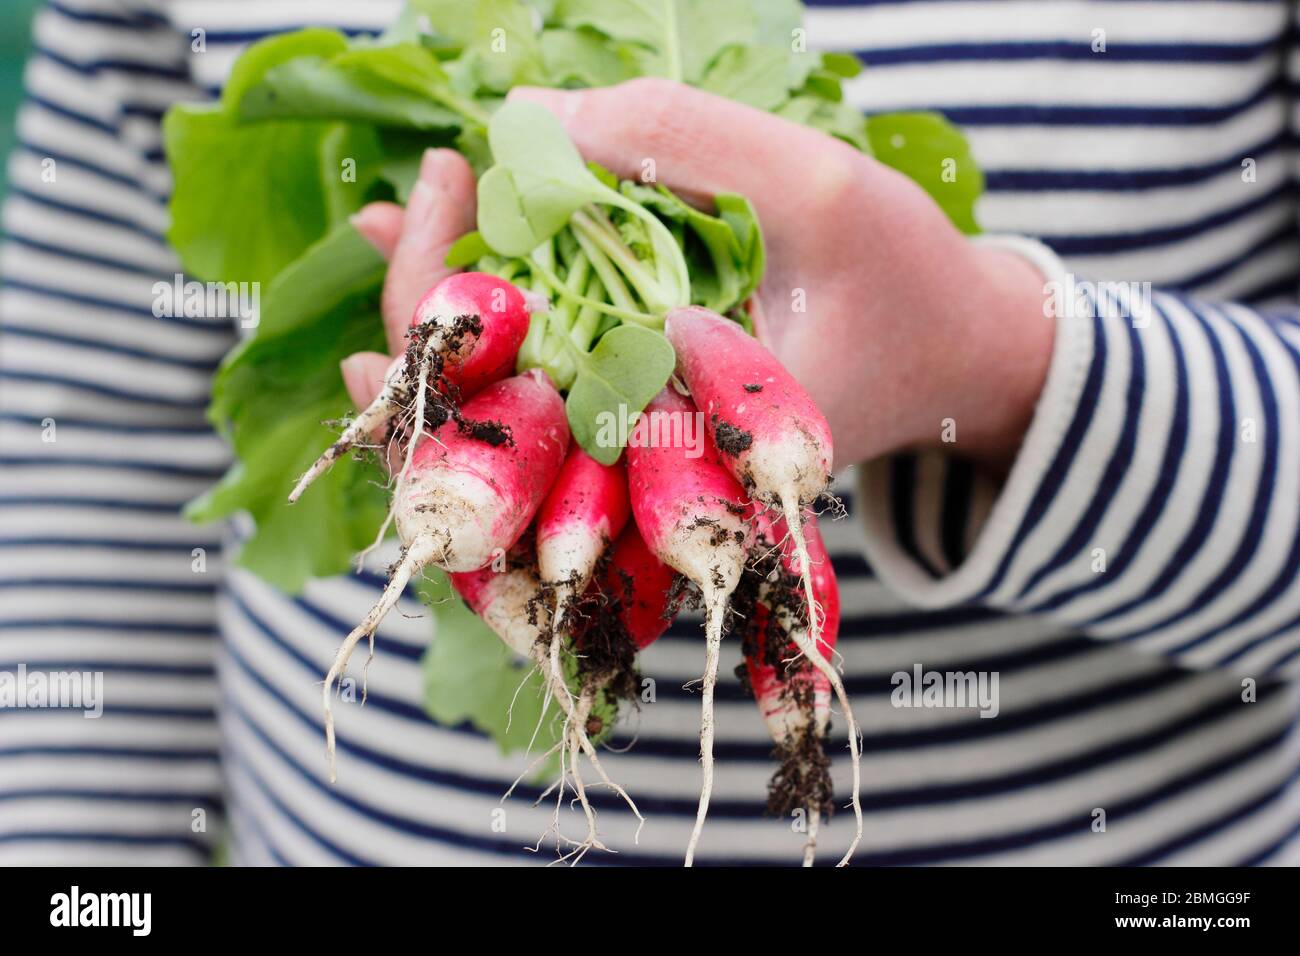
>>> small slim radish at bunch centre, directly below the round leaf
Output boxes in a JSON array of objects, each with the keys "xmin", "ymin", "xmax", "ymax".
[{"xmin": 537, "ymin": 445, "xmax": 629, "ymax": 712}]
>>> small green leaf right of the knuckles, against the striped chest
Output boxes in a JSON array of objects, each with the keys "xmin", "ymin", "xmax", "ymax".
[{"xmin": 867, "ymin": 113, "xmax": 984, "ymax": 234}]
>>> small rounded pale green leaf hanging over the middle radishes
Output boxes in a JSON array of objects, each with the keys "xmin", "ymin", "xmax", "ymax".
[{"xmin": 566, "ymin": 325, "xmax": 677, "ymax": 464}]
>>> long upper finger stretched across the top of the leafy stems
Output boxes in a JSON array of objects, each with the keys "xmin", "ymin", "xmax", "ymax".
[{"xmin": 510, "ymin": 78, "xmax": 863, "ymax": 226}]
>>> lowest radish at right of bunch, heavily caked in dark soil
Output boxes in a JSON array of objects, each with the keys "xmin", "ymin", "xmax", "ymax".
[{"xmin": 742, "ymin": 514, "xmax": 853, "ymax": 866}]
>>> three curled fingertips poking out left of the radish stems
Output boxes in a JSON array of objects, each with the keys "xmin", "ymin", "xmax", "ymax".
[{"xmin": 341, "ymin": 150, "xmax": 476, "ymax": 434}]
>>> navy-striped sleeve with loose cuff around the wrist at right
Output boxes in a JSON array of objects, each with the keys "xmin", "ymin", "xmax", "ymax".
[{"xmin": 858, "ymin": 231, "xmax": 1300, "ymax": 675}]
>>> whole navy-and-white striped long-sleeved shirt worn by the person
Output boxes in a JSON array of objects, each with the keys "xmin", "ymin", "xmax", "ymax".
[{"xmin": 0, "ymin": 0, "xmax": 1300, "ymax": 865}]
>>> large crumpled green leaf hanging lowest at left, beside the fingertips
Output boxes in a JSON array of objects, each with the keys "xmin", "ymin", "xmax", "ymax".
[{"xmin": 186, "ymin": 225, "xmax": 386, "ymax": 592}]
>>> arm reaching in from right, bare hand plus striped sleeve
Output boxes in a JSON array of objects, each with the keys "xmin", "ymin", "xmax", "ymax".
[{"xmin": 515, "ymin": 81, "xmax": 1300, "ymax": 674}]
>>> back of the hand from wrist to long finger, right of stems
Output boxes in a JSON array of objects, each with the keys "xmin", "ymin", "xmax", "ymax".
[{"xmin": 511, "ymin": 79, "xmax": 1053, "ymax": 467}]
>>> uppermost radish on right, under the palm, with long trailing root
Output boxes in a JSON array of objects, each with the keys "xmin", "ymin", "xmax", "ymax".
[{"xmin": 664, "ymin": 307, "xmax": 862, "ymax": 862}]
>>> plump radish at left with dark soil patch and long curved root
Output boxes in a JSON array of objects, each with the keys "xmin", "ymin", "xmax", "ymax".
[{"xmin": 322, "ymin": 369, "xmax": 569, "ymax": 780}]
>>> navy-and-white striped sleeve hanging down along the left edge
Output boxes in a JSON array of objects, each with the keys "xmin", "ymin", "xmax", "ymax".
[{"xmin": 0, "ymin": 0, "xmax": 231, "ymax": 865}]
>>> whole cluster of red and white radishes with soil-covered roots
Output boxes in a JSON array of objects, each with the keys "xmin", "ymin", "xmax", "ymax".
[{"xmin": 290, "ymin": 273, "xmax": 862, "ymax": 865}]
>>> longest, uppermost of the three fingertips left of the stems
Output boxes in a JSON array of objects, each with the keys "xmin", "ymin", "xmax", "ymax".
[{"xmin": 379, "ymin": 150, "xmax": 476, "ymax": 354}]
